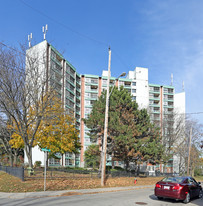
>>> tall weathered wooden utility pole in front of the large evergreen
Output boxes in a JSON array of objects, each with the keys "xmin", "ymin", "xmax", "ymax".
[{"xmin": 101, "ymin": 47, "xmax": 111, "ymax": 186}]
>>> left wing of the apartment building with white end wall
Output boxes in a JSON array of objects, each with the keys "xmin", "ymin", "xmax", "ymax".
[{"xmin": 25, "ymin": 40, "xmax": 81, "ymax": 166}]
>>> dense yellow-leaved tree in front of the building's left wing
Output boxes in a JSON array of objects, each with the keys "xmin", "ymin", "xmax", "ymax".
[{"xmin": 37, "ymin": 100, "xmax": 81, "ymax": 154}]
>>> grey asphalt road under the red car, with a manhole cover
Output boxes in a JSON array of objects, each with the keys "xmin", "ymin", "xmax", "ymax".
[{"xmin": 0, "ymin": 188, "xmax": 203, "ymax": 206}]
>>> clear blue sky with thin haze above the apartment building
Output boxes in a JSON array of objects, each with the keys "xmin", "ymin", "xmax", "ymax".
[{"xmin": 0, "ymin": 0, "xmax": 203, "ymax": 123}]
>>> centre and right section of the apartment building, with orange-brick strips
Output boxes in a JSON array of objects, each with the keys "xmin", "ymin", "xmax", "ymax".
[{"xmin": 81, "ymin": 67, "xmax": 185, "ymax": 173}]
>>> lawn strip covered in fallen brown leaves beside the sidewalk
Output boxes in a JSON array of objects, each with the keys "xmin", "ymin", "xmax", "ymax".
[{"xmin": 0, "ymin": 171, "xmax": 162, "ymax": 192}]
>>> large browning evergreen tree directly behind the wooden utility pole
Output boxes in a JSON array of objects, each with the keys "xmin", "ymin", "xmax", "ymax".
[{"xmin": 85, "ymin": 87, "xmax": 163, "ymax": 169}]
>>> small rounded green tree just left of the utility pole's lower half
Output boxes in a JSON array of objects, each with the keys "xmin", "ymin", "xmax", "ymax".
[{"xmin": 85, "ymin": 144, "xmax": 101, "ymax": 169}]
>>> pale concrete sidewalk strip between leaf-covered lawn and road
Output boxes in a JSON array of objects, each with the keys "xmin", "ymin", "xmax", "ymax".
[{"xmin": 0, "ymin": 185, "xmax": 154, "ymax": 199}]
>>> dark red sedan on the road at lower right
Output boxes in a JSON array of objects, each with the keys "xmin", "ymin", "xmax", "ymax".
[{"xmin": 154, "ymin": 177, "xmax": 203, "ymax": 203}]
